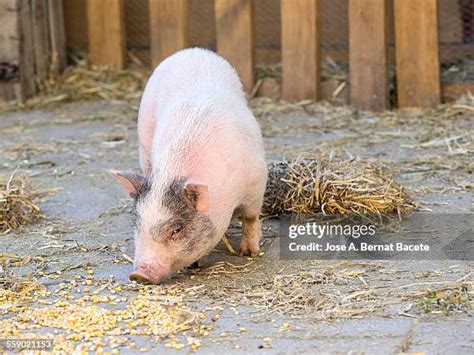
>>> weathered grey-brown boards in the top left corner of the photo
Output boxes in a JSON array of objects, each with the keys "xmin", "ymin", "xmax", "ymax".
[{"xmin": 0, "ymin": 0, "xmax": 66, "ymax": 101}]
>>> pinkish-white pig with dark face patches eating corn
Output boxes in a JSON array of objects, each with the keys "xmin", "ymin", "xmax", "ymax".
[{"xmin": 112, "ymin": 48, "xmax": 267, "ymax": 283}]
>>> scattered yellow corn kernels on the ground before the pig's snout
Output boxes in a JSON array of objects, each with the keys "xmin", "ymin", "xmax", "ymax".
[{"xmin": 0, "ymin": 271, "xmax": 209, "ymax": 353}]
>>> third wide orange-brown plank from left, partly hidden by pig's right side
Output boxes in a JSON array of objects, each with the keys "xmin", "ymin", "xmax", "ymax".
[{"xmin": 215, "ymin": 0, "xmax": 255, "ymax": 93}]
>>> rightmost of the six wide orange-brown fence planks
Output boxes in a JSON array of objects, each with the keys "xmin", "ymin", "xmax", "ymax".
[{"xmin": 394, "ymin": 0, "xmax": 440, "ymax": 107}]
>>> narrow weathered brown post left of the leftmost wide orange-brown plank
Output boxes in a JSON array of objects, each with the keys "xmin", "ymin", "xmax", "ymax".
[{"xmin": 48, "ymin": 0, "xmax": 67, "ymax": 74}]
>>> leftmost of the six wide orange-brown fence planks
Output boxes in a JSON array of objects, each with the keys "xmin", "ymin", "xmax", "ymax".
[{"xmin": 87, "ymin": 0, "xmax": 126, "ymax": 69}]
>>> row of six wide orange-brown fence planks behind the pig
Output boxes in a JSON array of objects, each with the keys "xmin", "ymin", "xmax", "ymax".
[{"xmin": 1, "ymin": 0, "xmax": 474, "ymax": 111}]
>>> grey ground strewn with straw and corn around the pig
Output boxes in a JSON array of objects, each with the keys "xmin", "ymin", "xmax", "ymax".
[{"xmin": 0, "ymin": 99, "xmax": 474, "ymax": 354}]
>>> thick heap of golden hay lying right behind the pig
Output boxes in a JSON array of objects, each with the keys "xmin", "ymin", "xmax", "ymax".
[{"xmin": 263, "ymin": 156, "xmax": 415, "ymax": 216}]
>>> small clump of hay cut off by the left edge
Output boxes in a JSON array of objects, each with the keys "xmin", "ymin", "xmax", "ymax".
[{"xmin": 0, "ymin": 175, "xmax": 43, "ymax": 233}]
